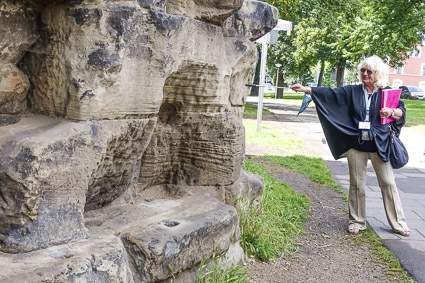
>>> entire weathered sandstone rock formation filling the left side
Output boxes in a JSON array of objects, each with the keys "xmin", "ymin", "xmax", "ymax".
[{"xmin": 0, "ymin": 0, "xmax": 277, "ymax": 282}]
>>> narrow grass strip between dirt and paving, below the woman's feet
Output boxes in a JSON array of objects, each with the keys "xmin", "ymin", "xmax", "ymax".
[{"xmin": 355, "ymin": 229, "xmax": 415, "ymax": 283}]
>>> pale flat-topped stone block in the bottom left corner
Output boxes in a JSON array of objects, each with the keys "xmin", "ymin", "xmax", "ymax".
[{"xmin": 0, "ymin": 235, "xmax": 134, "ymax": 283}]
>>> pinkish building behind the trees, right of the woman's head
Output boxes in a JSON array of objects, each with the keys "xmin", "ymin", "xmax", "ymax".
[{"xmin": 388, "ymin": 41, "xmax": 425, "ymax": 92}]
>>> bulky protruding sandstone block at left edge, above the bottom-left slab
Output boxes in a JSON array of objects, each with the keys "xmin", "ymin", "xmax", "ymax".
[{"xmin": 0, "ymin": 116, "xmax": 155, "ymax": 253}]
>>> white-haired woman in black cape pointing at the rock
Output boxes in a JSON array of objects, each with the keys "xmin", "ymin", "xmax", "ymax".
[{"xmin": 291, "ymin": 56, "xmax": 410, "ymax": 237}]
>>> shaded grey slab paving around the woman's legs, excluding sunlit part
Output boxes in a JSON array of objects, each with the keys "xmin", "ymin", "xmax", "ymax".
[{"xmin": 326, "ymin": 161, "xmax": 425, "ymax": 283}]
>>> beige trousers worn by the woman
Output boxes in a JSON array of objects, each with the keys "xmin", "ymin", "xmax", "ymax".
[{"xmin": 347, "ymin": 149, "xmax": 409, "ymax": 232}]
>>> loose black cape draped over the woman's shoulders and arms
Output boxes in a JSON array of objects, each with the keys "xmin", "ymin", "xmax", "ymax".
[{"xmin": 312, "ymin": 84, "xmax": 406, "ymax": 162}]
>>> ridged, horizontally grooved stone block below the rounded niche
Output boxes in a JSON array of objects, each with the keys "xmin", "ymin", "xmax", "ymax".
[{"xmin": 139, "ymin": 113, "xmax": 244, "ymax": 191}]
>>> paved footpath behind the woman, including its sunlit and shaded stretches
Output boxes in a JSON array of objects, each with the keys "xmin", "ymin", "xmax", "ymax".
[{"xmin": 248, "ymin": 97, "xmax": 425, "ymax": 283}]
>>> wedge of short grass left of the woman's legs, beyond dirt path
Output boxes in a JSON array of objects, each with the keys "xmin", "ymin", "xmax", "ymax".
[{"xmin": 264, "ymin": 155, "xmax": 343, "ymax": 193}]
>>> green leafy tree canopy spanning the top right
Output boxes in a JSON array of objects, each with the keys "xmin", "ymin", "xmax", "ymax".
[{"xmin": 266, "ymin": 0, "xmax": 425, "ymax": 85}]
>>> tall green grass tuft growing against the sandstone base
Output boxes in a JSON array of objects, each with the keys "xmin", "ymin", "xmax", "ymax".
[{"xmin": 240, "ymin": 161, "xmax": 309, "ymax": 262}]
